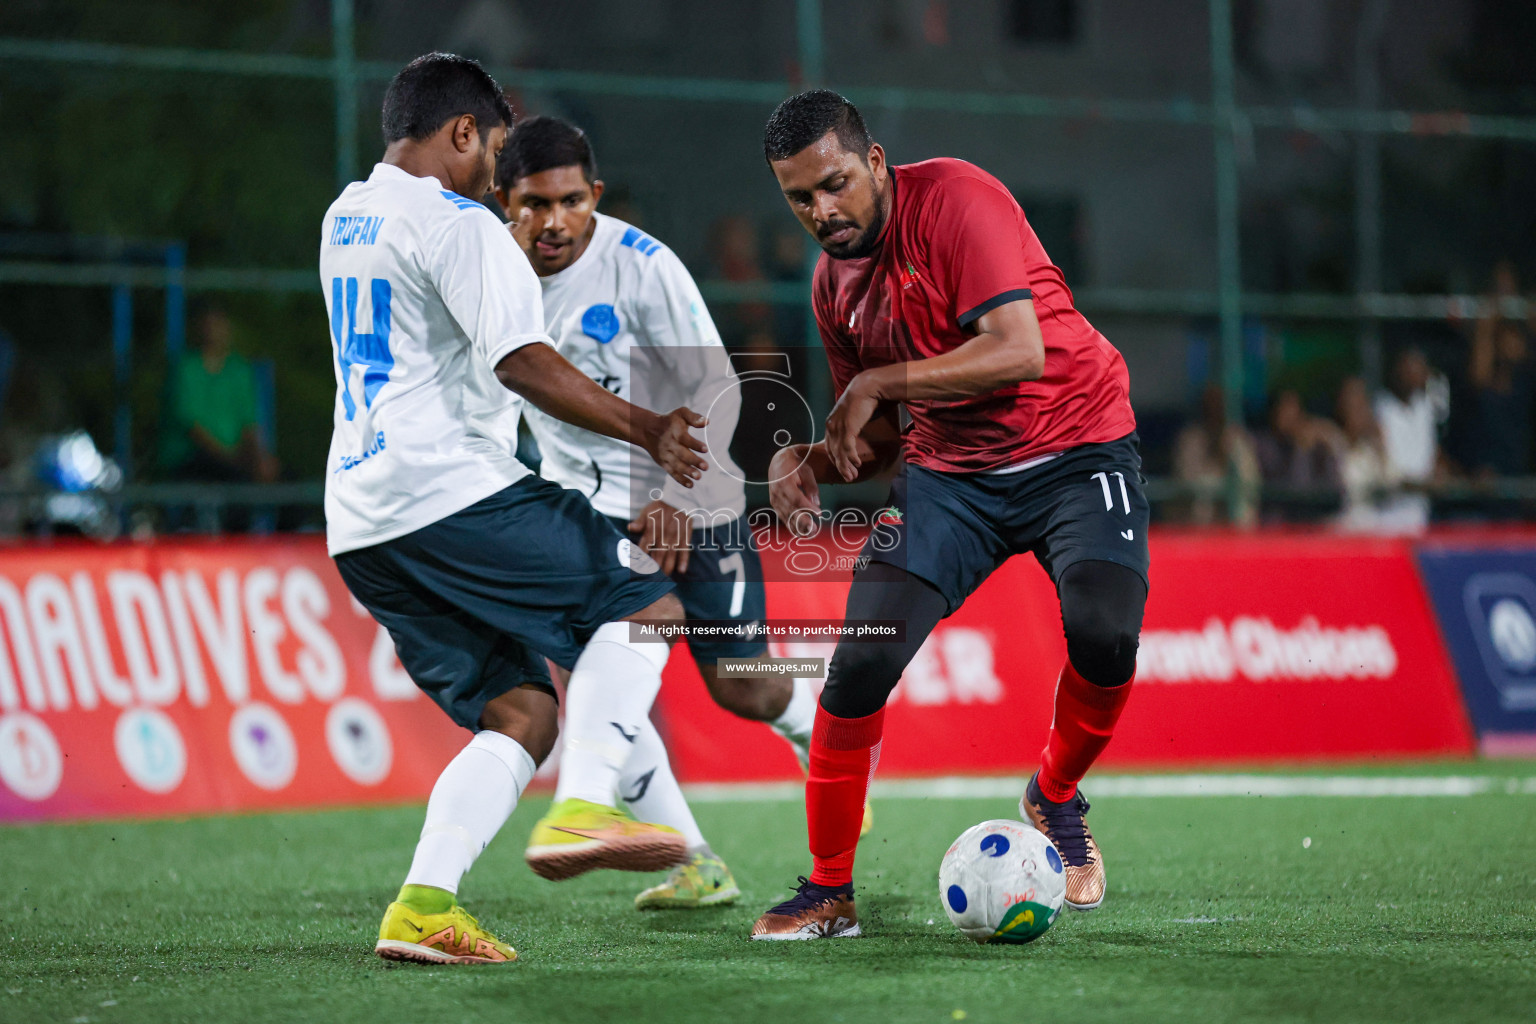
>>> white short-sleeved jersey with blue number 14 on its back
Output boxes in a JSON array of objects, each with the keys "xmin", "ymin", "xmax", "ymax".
[{"xmin": 319, "ymin": 164, "xmax": 548, "ymax": 554}]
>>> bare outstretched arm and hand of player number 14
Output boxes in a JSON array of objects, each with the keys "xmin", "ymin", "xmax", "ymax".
[{"xmin": 496, "ymin": 342, "xmax": 710, "ymax": 487}]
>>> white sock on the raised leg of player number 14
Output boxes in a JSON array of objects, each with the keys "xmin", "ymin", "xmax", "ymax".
[{"xmin": 554, "ymin": 622, "xmax": 670, "ymax": 808}]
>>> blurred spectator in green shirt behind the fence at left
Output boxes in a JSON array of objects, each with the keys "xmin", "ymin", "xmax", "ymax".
[{"xmin": 160, "ymin": 306, "xmax": 278, "ymax": 484}]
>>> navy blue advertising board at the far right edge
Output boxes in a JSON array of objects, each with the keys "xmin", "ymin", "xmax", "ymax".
[{"xmin": 1419, "ymin": 539, "xmax": 1536, "ymax": 757}]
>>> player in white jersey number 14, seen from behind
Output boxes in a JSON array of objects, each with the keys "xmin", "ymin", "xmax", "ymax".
[{"xmin": 319, "ymin": 54, "xmax": 708, "ymax": 963}]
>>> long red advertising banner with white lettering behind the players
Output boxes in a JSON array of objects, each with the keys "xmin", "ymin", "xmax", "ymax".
[{"xmin": 0, "ymin": 534, "xmax": 1474, "ymax": 820}]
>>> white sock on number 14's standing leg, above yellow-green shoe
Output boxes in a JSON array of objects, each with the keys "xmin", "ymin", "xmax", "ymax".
[{"xmin": 406, "ymin": 729, "xmax": 538, "ymax": 892}]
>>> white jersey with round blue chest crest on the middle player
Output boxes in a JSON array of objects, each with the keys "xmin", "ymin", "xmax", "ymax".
[{"xmin": 527, "ymin": 213, "xmax": 746, "ymax": 525}]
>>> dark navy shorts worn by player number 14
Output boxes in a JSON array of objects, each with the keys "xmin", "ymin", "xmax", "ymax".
[{"xmin": 336, "ymin": 476, "xmax": 673, "ymax": 729}]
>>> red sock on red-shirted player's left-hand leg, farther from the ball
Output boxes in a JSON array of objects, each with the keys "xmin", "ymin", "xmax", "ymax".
[{"xmin": 805, "ymin": 705, "xmax": 885, "ymax": 886}]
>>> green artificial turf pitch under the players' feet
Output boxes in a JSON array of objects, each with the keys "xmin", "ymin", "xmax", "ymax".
[{"xmin": 0, "ymin": 765, "xmax": 1536, "ymax": 1024}]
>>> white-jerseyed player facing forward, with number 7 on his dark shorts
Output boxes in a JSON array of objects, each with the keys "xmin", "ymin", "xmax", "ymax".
[{"xmin": 496, "ymin": 117, "xmax": 872, "ymax": 909}]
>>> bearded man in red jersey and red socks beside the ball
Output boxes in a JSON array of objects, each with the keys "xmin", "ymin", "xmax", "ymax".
[{"xmin": 753, "ymin": 89, "xmax": 1147, "ymax": 940}]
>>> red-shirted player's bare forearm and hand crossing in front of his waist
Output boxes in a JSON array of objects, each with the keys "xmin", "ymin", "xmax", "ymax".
[{"xmin": 825, "ymin": 298, "xmax": 1046, "ymax": 481}]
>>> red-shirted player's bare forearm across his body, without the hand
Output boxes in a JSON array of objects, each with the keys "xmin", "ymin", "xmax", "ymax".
[{"xmin": 856, "ymin": 299, "xmax": 1046, "ymax": 402}]
